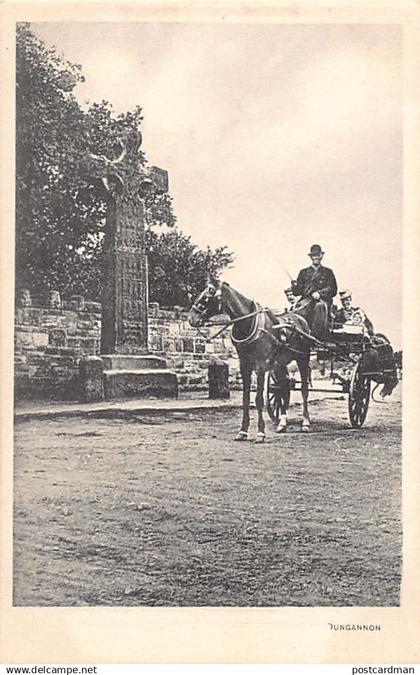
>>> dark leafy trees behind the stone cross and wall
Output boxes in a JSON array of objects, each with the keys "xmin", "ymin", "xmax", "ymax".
[{"xmin": 16, "ymin": 23, "xmax": 231, "ymax": 304}]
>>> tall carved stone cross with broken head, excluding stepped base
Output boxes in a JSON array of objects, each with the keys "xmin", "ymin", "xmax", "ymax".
[{"xmin": 86, "ymin": 136, "xmax": 168, "ymax": 354}]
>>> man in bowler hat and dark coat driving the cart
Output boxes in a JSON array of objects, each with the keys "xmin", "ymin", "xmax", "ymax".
[{"xmin": 292, "ymin": 244, "xmax": 337, "ymax": 340}]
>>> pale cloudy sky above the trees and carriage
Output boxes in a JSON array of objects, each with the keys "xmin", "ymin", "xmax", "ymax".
[{"xmin": 32, "ymin": 22, "xmax": 402, "ymax": 348}]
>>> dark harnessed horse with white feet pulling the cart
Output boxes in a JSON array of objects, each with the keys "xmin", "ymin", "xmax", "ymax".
[{"xmin": 188, "ymin": 277, "xmax": 310, "ymax": 443}]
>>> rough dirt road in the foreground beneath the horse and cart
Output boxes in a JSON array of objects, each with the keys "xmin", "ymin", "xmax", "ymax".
[{"xmin": 14, "ymin": 392, "xmax": 402, "ymax": 606}]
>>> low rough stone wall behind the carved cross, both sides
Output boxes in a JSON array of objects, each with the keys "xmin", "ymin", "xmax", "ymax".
[{"xmin": 15, "ymin": 294, "xmax": 239, "ymax": 400}]
